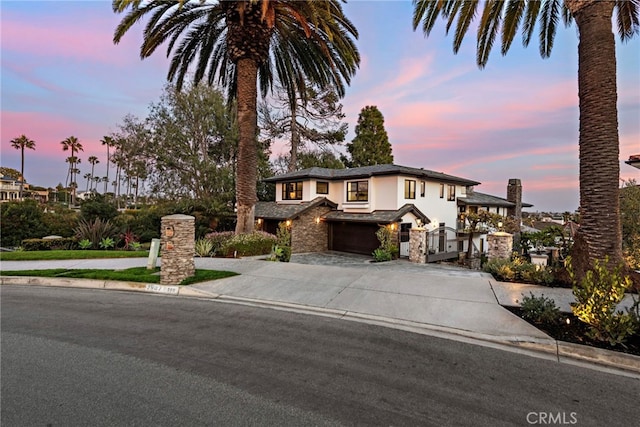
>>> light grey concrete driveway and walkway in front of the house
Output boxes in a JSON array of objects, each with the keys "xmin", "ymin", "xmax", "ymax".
[{"xmin": 0, "ymin": 254, "xmax": 640, "ymax": 374}]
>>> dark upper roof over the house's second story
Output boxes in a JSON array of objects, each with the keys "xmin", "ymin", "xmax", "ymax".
[{"xmin": 263, "ymin": 164, "xmax": 480, "ymax": 185}]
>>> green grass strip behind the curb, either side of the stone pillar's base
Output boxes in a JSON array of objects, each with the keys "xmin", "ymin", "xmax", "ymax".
[{"xmin": 0, "ymin": 267, "xmax": 237, "ymax": 286}]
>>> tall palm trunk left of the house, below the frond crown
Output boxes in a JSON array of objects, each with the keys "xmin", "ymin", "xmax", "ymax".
[{"xmin": 236, "ymin": 58, "xmax": 258, "ymax": 234}]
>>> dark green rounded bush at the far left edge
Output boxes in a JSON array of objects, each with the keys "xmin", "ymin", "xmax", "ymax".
[{"xmin": 0, "ymin": 200, "xmax": 49, "ymax": 247}]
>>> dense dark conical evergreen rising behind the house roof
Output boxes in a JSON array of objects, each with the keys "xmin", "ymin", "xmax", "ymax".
[{"xmin": 341, "ymin": 105, "xmax": 393, "ymax": 168}]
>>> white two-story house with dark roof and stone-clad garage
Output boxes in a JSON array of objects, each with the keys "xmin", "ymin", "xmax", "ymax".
[{"xmin": 255, "ymin": 164, "xmax": 531, "ymax": 261}]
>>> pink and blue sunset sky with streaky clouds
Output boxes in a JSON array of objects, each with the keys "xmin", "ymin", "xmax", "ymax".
[{"xmin": 0, "ymin": 0, "xmax": 640, "ymax": 211}]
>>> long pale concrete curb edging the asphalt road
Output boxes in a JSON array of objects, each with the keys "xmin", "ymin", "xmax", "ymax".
[{"xmin": 0, "ymin": 276, "xmax": 640, "ymax": 379}]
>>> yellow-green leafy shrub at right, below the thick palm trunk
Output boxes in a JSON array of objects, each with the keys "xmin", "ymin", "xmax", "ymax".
[{"xmin": 567, "ymin": 257, "xmax": 638, "ymax": 345}]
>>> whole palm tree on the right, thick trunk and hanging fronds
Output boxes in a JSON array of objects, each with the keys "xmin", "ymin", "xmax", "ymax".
[{"xmin": 413, "ymin": 0, "xmax": 640, "ymax": 272}]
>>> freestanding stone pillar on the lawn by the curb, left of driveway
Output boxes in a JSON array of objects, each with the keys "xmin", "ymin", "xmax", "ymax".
[{"xmin": 160, "ymin": 214, "xmax": 196, "ymax": 285}]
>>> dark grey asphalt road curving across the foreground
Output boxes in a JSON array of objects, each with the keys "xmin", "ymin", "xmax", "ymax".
[{"xmin": 0, "ymin": 286, "xmax": 640, "ymax": 426}]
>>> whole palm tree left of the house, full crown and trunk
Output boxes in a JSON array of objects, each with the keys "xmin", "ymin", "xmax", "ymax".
[{"xmin": 113, "ymin": 0, "xmax": 360, "ymax": 233}]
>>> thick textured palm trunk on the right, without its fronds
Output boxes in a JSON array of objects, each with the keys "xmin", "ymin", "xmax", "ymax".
[{"xmin": 574, "ymin": 1, "xmax": 622, "ymax": 267}]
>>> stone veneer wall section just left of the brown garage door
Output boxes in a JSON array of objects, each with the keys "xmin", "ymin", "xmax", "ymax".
[{"xmin": 291, "ymin": 206, "xmax": 331, "ymax": 253}]
